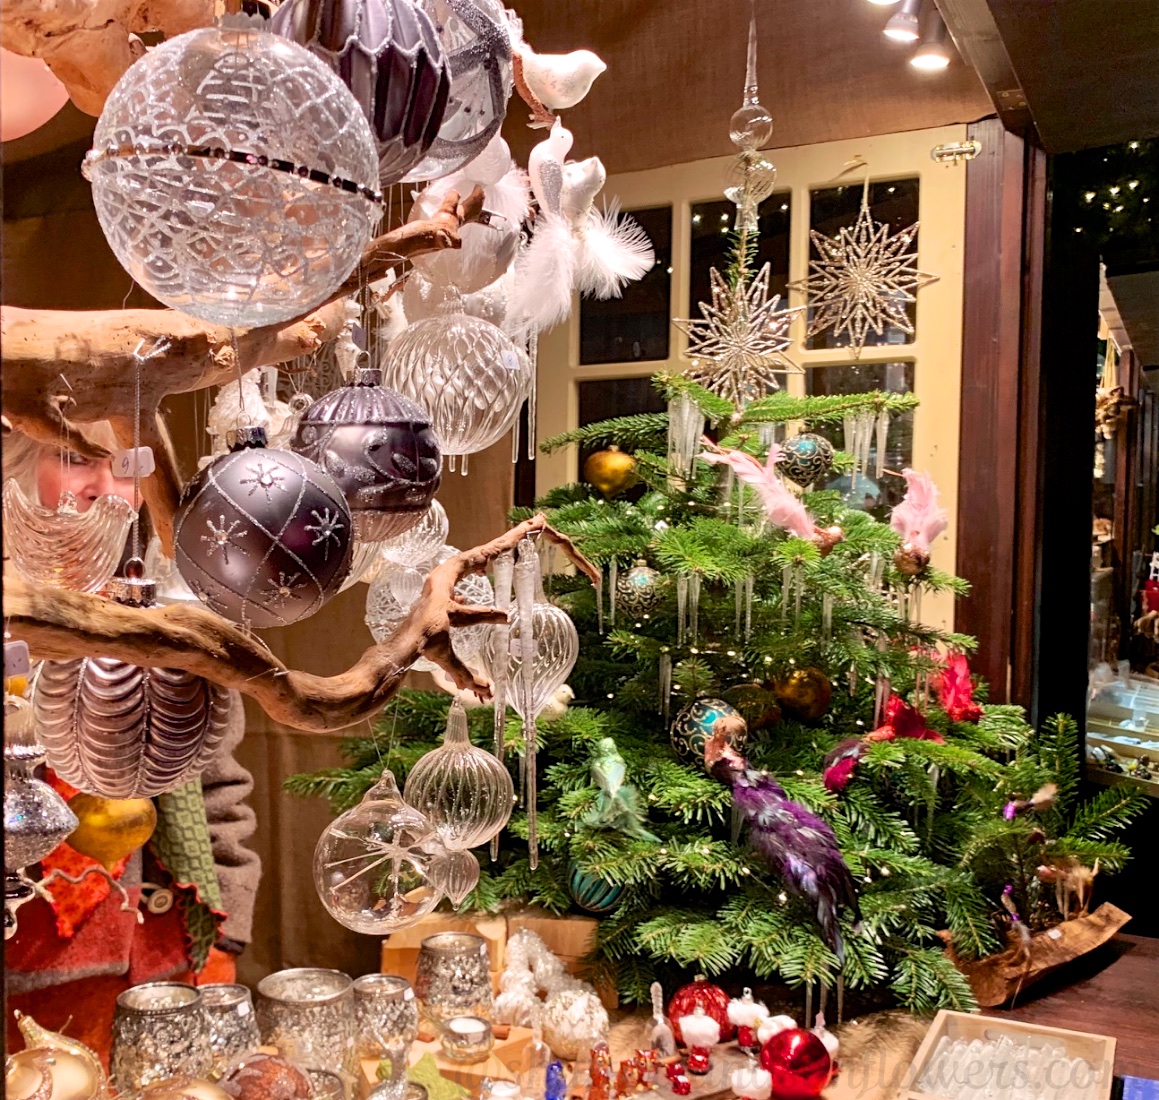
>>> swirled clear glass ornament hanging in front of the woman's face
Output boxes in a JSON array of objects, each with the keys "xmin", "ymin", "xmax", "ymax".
[{"xmin": 3, "ymin": 479, "xmax": 137, "ymax": 592}]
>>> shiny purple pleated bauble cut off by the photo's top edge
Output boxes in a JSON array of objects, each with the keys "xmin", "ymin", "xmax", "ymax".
[{"xmin": 270, "ymin": 0, "xmax": 451, "ymax": 188}]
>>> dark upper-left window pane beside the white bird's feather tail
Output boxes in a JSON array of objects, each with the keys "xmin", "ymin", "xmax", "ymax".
[{"xmin": 580, "ymin": 206, "xmax": 672, "ymax": 364}]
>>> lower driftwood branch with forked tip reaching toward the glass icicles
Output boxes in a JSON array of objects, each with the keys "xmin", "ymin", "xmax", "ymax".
[{"xmin": 3, "ymin": 515, "xmax": 599, "ymax": 731}]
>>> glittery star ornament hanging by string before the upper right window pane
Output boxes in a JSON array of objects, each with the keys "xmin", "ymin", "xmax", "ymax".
[{"xmin": 788, "ymin": 198, "xmax": 938, "ymax": 358}]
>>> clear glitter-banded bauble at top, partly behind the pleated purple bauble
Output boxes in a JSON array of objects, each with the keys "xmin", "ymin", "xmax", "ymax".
[{"xmin": 403, "ymin": 0, "xmax": 512, "ymax": 182}]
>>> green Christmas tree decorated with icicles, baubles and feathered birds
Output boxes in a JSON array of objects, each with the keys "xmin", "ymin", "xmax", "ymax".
[{"xmin": 289, "ymin": 368, "xmax": 1144, "ymax": 1010}]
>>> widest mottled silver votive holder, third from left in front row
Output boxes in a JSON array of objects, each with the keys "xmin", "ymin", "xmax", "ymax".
[{"xmin": 257, "ymin": 967, "xmax": 358, "ymax": 1085}]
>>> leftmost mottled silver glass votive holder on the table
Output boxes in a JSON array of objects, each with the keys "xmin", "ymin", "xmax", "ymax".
[{"xmin": 109, "ymin": 982, "xmax": 213, "ymax": 1095}]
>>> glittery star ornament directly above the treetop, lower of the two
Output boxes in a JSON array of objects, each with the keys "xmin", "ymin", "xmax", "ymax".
[{"xmin": 672, "ymin": 263, "xmax": 804, "ymax": 408}]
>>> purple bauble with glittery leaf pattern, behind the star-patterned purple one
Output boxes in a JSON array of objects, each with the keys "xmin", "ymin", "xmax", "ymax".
[{"xmin": 291, "ymin": 367, "xmax": 443, "ymax": 542}]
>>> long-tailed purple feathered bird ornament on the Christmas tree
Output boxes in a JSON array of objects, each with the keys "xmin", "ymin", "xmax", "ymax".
[{"xmin": 705, "ymin": 717, "xmax": 861, "ymax": 960}]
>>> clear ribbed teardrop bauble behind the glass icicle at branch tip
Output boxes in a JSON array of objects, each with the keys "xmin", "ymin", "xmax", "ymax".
[{"xmin": 482, "ymin": 582, "xmax": 580, "ymax": 721}]
